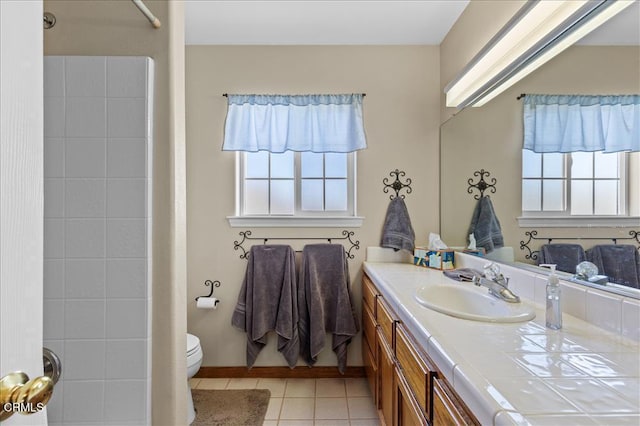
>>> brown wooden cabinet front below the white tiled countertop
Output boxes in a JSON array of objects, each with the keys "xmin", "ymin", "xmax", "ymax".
[{"xmin": 362, "ymin": 274, "xmax": 479, "ymax": 426}]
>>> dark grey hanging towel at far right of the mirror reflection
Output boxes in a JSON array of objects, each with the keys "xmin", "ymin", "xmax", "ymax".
[{"xmin": 587, "ymin": 244, "xmax": 640, "ymax": 288}]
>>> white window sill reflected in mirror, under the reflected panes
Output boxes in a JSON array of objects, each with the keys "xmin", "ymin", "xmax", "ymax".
[{"xmin": 518, "ymin": 216, "xmax": 640, "ymax": 228}]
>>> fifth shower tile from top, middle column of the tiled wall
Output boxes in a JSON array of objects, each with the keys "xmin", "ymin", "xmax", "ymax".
[{"xmin": 65, "ymin": 219, "xmax": 105, "ymax": 258}]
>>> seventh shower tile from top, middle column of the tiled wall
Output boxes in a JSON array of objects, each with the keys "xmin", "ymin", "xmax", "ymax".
[{"xmin": 64, "ymin": 300, "xmax": 105, "ymax": 339}]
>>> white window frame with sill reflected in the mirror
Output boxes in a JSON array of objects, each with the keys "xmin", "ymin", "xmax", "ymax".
[{"xmin": 518, "ymin": 150, "xmax": 640, "ymax": 228}]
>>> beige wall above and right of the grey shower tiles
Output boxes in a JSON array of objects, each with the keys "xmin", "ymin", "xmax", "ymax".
[{"xmin": 44, "ymin": 0, "xmax": 186, "ymax": 425}]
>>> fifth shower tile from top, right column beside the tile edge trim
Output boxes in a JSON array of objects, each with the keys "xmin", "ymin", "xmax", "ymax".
[{"xmin": 107, "ymin": 219, "xmax": 147, "ymax": 257}]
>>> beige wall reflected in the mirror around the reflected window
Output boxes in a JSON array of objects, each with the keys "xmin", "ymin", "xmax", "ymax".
[{"xmin": 440, "ymin": 4, "xmax": 640, "ymax": 298}]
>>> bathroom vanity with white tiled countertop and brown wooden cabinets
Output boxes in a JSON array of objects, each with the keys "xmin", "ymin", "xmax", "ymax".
[{"xmin": 362, "ymin": 261, "xmax": 640, "ymax": 425}]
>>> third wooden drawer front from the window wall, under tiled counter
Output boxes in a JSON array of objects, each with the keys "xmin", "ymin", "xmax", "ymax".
[{"xmin": 396, "ymin": 325, "xmax": 434, "ymax": 419}]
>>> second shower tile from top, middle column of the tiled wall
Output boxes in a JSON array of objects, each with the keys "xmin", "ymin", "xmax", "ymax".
[{"xmin": 65, "ymin": 98, "xmax": 107, "ymax": 138}]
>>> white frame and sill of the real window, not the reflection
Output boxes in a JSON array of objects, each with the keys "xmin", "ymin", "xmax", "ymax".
[{"xmin": 227, "ymin": 151, "xmax": 364, "ymax": 228}]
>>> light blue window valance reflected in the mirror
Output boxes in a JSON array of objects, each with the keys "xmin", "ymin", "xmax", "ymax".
[{"xmin": 524, "ymin": 95, "xmax": 640, "ymax": 153}]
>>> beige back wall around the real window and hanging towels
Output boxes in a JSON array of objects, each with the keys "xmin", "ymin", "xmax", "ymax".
[{"xmin": 186, "ymin": 46, "xmax": 440, "ymax": 366}]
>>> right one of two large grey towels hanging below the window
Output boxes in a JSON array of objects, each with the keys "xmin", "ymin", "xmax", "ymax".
[{"xmin": 298, "ymin": 244, "xmax": 359, "ymax": 374}]
